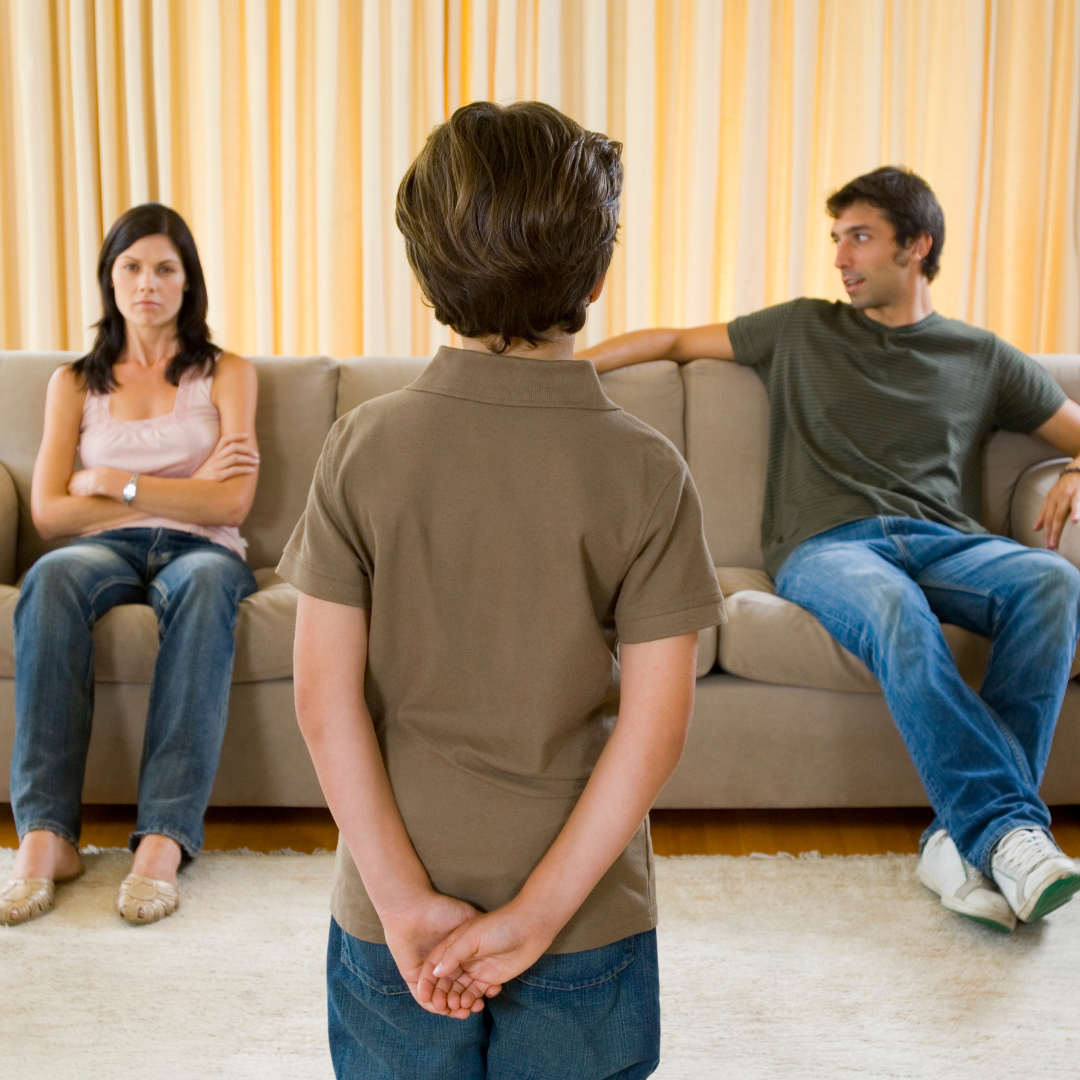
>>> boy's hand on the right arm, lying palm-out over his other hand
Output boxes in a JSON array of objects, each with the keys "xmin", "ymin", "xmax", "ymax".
[{"xmin": 416, "ymin": 903, "xmax": 554, "ymax": 1015}]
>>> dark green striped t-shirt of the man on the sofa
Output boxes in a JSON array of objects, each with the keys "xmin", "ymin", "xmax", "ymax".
[{"xmin": 728, "ymin": 298, "xmax": 1065, "ymax": 576}]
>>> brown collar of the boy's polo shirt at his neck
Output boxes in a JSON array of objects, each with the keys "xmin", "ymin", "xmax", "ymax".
[{"xmin": 408, "ymin": 346, "xmax": 619, "ymax": 411}]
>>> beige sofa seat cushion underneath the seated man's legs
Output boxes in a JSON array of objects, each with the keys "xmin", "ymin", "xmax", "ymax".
[{"xmin": 716, "ymin": 567, "xmax": 1028, "ymax": 693}]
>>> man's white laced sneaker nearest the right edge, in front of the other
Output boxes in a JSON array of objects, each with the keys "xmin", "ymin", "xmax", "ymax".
[{"xmin": 990, "ymin": 828, "xmax": 1080, "ymax": 922}]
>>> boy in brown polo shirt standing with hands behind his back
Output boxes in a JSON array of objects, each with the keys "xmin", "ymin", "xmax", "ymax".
[{"xmin": 280, "ymin": 103, "xmax": 724, "ymax": 1080}]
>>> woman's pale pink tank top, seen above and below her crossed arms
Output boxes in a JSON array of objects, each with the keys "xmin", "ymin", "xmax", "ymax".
[{"xmin": 79, "ymin": 374, "xmax": 247, "ymax": 558}]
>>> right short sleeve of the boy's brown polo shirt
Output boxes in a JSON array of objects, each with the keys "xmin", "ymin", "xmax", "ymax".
[{"xmin": 615, "ymin": 462, "xmax": 727, "ymax": 645}]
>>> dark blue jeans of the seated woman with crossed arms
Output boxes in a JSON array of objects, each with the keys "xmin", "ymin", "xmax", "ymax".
[{"xmin": 11, "ymin": 528, "xmax": 257, "ymax": 858}]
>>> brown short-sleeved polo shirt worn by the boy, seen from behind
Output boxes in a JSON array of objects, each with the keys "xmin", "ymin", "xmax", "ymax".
[{"xmin": 279, "ymin": 349, "xmax": 725, "ymax": 953}]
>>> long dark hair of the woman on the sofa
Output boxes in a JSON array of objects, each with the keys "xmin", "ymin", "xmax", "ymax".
[{"xmin": 71, "ymin": 203, "xmax": 221, "ymax": 394}]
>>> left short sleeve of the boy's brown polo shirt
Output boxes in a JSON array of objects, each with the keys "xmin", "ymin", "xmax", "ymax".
[{"xmin": 278, "ymin": 418, "xmax": 373, "ymax": 609}]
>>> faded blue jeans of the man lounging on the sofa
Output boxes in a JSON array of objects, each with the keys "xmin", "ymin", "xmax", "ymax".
[{"xmin": 777, "ymin": 517, "xmax": 1080, "ymax": 874}]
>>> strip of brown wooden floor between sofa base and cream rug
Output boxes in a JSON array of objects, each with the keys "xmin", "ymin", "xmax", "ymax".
[{"xmin": 0, "ymin": 804, "xmax": 1080, "ymax": 858}]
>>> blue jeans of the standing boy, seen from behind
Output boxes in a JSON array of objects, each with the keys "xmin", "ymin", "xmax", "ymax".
[{"xmin": 326, "ymin": 919, "xmax": 660, "ymax": 1080}]
